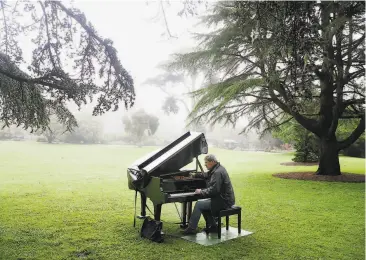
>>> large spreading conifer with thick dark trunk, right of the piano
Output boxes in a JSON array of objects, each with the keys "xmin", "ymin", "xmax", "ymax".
[{"xmin": 170, "ymin": 1, "xmax": 365, "ymax": 175}]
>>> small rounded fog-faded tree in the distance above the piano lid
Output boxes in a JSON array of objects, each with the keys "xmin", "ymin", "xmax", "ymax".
[{"xmin": 122, "ymin": 109, "xmax": 159, "ymax": 145}]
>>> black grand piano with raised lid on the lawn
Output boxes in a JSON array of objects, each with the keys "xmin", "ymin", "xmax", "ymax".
[{"xmin": 127, "ymin": 132, "xmax": 208, "ymax": 228}]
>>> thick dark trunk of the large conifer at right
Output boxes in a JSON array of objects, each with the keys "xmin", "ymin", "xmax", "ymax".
[{"xmin": 316, "ymin": 137, "xmax": 341, "ymax": 175}]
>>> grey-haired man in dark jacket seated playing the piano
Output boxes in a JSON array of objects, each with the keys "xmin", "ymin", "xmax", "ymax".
[{"xmin": 183, "ymin": 154, "xmax": 235, "ymax": 235}]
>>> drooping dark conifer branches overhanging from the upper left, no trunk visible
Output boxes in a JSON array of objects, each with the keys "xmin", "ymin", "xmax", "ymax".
[{"xmin": 0, "ymin": 0, "xmax": 135, "ymax": 131}]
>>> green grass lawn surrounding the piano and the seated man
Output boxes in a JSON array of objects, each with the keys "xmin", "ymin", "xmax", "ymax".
[{"xmin": 0, "ymin": 142, "xmax": 365, "ymax": 260}]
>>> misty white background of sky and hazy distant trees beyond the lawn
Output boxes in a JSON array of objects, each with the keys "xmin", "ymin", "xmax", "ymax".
[{"xmin": 2, "ymin": 1, "xmax": 281, "ymax": 150}]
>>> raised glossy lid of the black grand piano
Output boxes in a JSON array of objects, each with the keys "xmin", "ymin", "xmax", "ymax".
[{"xmin": 134, "ymin": 132, "xmax": 208, "ymax": 176}]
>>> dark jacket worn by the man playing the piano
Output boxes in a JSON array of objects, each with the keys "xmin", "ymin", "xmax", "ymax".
[{"xmin": 199, "ymin": 163, "xmax": 235, "ymax": 215}]
